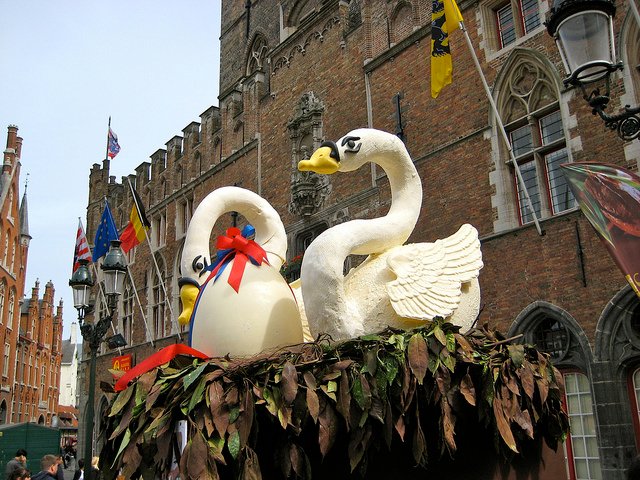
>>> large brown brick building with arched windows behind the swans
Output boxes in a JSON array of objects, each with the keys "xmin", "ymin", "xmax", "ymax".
[{"xmin": 80, "ymin": 0, "xmax": 640, "ymax": 479}]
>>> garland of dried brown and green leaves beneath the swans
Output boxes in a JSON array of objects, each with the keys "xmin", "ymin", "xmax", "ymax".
[{"xmin": 101, "ymin": 320, "xmax": 568, "ymax": 479}]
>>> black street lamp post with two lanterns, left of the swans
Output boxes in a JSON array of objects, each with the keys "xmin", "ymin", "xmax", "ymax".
[{"xmin": 69, "ymin": 240, "xmax": 127, "ymax": 471}]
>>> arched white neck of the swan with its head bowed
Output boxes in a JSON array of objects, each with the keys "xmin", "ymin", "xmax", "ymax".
[{"xmin": 181, "ymin": 187, "xmax": 287, "ymax": 275}]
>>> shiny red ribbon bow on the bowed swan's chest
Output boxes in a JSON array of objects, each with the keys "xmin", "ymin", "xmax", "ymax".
[{"xmin": 211, "ymin": 227, "xmax": 269, "ymax": 293}]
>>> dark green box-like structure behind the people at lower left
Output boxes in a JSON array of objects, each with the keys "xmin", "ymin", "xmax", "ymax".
[{"xmin": 0, "ymin": 423, "xmax": 60, "ymax": 472}]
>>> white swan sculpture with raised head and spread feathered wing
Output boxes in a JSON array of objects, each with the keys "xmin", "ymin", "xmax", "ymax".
[{"xmin": 298, "ymin": 129, "xmax": 483, "ymax": 340}]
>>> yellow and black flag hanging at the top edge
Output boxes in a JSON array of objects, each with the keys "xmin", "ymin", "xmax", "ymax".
[{"xmin": 431, "ymin": 0, "xmax": 462, "ymax": 98}]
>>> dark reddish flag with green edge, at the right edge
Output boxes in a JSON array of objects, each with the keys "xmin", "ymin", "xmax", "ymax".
[{"xmin": 562, "ymin": 162, "xmax": 640, "ymax": 297}]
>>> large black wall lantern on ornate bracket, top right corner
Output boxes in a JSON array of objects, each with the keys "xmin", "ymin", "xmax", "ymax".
[{"xmin": 546, "ymin": 0, "xmax": 640, "ymax": 140}]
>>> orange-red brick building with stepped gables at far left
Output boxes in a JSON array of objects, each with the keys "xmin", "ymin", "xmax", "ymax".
[{"xmin": 0, "ymin": 125, "xmax": 62, "ymax": 425}]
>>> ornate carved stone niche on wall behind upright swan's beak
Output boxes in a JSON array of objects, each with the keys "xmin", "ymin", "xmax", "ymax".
[{"xmin": 287, "ymin": 92, "xmax": 331, "ymax": 217}]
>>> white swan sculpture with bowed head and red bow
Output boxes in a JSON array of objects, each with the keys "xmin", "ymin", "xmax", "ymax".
[{"xmin": 178, "ymin": 187, "xmax": 303, "ymax": 357}]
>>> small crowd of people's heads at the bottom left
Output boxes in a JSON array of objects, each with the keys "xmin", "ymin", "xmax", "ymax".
[{"xmin": 5, "ymin": 448, "xmax": 101, "ymax": 480}]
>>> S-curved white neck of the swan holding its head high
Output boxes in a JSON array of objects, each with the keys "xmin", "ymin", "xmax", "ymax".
[{"xmin": 301, "ymin": 150, "xmax": 422, "ymax": 337}]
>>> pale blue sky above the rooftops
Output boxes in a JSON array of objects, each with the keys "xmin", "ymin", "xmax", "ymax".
[{"xmin": 0, "ymin": 0, "xmax": 220, "ymax": 339}]
